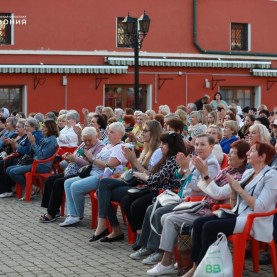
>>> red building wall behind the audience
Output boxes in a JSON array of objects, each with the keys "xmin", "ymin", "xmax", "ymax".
[{"xmin": 0, "ymin": 0, "xmax": 277, "ymax": 112}]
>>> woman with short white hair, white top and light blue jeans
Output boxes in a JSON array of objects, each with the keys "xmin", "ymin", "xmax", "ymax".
[{"xmin": 60, "ymin": 122, "xmax": 127, "ymax": 227}]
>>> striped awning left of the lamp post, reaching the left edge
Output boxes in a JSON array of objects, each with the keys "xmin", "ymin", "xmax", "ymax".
[{"xmin": 0, "ymin": 64, "xmax": 128, "ymax": 74}]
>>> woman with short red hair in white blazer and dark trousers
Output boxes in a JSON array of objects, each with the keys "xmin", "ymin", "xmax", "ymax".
[{"xmin": 184, "ymin": 142, "xmax": 277, "ymax": 277}]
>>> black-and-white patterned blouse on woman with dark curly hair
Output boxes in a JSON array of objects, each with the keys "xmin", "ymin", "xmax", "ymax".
[{"xmin": 146, "ymin": 156, "xmax": 180, "ymax": 190}]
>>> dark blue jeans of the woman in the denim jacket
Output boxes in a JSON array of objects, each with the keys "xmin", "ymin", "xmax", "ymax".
[{"xmin": 6, "ymin": 164, "xmax": 49, "ymax": 187}]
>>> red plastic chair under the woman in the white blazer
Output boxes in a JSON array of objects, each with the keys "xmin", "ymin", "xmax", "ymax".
[{"xmin": 228, "ymin": 208, "xmax": 277, "ymax": 277}]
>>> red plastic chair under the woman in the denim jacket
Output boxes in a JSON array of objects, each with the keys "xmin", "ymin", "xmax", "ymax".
[{"xmin": 16, "ymin": 146, "xmax": 59, "ymax": 202}]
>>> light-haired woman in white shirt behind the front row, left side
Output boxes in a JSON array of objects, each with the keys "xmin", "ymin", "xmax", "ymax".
[{"xmin": 58, "ymin": 110, "xmax": 80, "ymax": 147}]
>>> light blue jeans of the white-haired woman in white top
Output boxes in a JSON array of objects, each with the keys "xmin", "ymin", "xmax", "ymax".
[{"xmin": 64, "ymin": 174, "xmax": 102, "ymax": 218}]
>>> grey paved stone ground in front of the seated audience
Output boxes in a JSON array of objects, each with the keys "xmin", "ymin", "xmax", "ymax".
[{"xmin": 0, "ymin": 195, "xmax": 273, "ymax": 277}]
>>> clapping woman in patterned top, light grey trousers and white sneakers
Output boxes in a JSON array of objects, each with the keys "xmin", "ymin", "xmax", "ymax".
[{"xmin": 144, "ymin": 140, "xmax": 250, "ymax": 275}]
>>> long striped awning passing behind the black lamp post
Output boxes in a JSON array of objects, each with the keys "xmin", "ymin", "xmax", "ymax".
[{"xmin": 105, "ymin": 57, "xmax": 271, "ymax": 68}]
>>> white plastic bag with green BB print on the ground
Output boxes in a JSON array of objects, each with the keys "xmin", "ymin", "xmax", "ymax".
[{"xmin": 193, "ymin": 233, "xmax": 233, "ymax": 277}]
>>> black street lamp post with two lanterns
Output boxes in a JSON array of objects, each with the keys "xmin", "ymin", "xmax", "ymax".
[{"xmin": 122, "ymin": 12, "xmax": 150, "ymax": 110}]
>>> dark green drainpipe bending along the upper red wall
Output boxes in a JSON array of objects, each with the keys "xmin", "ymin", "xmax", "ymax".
[{"xmin": 193, "ymin": 0, "xmax": 277, "ymax": 57}]
